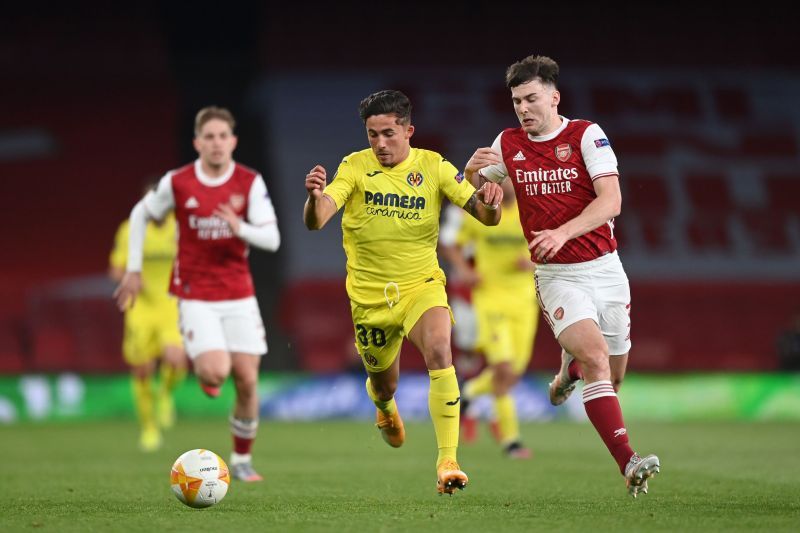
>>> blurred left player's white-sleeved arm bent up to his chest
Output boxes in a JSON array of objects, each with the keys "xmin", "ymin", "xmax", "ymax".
[{"xmin": 214, "ymin": 175, "xmax": 281, "ymax": 252}]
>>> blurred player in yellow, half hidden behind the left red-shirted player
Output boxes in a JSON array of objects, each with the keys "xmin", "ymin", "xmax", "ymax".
[{"xmin": 109, "ymin": 183, "xmax": 187, "ymax": 451}]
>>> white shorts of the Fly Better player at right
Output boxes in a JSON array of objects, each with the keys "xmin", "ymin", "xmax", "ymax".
[{"xmin": 535, "ymin": 252, "xmax": 631, "ymax": 355}]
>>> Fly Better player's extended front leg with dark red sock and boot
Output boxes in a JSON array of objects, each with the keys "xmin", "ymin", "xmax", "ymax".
[{"xmin": 558, "ymin": 319, "xmax": 660, "ymax": 495}]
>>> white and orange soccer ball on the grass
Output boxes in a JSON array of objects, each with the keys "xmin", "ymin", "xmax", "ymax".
[{"xmin": 169, "ymin": 450, "xmax": 231, "ymax": 509}]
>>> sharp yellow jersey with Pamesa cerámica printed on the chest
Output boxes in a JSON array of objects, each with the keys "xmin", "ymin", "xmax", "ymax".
[{"xmin": 324, "ymin": 148, "xmax": 476, "ymax": 306}]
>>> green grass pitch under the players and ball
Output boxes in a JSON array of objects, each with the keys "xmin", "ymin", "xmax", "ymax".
[{"xmin": 0, "ymin": 419, "xmax": 800, "ymax": 533}]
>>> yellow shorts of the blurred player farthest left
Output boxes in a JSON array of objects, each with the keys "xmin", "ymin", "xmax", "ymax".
[{"xmin": 122, "ymin": 301, "xmax": 183, "ymax": 366}]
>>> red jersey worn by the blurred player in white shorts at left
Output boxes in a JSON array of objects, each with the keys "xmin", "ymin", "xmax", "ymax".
[{"xmin": 145, "ymin": 161, "xmax": 274, "ymax": 301}]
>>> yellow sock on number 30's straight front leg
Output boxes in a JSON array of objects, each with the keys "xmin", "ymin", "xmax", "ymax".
[{"xmin": 428, "ymin": 366, "xmax": 461, "ymax": 465}]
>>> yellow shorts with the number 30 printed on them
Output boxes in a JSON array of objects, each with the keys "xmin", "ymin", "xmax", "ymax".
[{"xmin": 350, "ymin": 278, "xmax": 453, "ymax": 372}]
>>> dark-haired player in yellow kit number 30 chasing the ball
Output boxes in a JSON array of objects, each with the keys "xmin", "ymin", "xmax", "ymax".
[{"xmin": 303, "ymin": 91, "xmax": 502, "ymax": 494}]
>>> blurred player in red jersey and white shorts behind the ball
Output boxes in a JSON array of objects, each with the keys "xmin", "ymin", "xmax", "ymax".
[{"xmin": 114, "ymin": 107, "xmax": 280, "ymax": 481}]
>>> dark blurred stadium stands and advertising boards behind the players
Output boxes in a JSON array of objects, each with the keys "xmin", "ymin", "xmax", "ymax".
[{"xmin": 0, "ymin": 1, "xmax": 800, "ymax": 424}]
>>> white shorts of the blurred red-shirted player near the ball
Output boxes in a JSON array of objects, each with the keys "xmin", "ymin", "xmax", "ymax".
[{"xmin": 178, "ymin": 296, "xmax": 267, "ymax": 359}]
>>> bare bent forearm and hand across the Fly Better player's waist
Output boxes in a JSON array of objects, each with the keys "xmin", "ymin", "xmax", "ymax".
[{"xmin": 528, "ymin": 174, "xmax": 622, "ymax": 261}]
